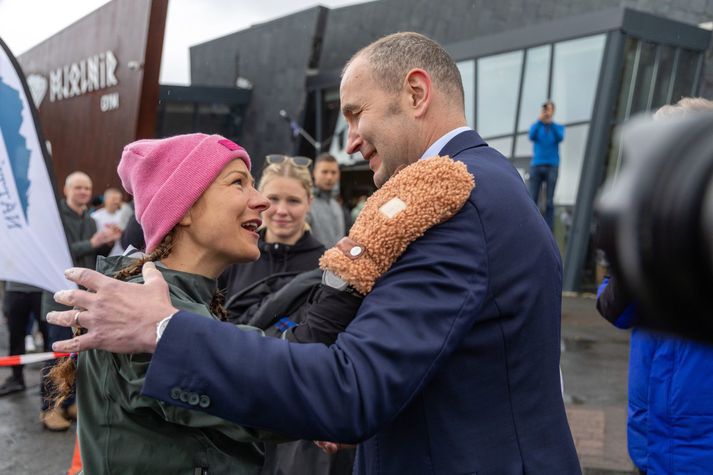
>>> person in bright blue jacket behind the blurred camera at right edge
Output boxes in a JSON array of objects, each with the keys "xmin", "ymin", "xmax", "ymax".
[{"xmin": 597, "ymin": 97, "xmax": 713, "ymax": 475}]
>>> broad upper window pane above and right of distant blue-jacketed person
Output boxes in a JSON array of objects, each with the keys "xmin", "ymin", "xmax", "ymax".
[{"xmin": 552, "ymin": 35, "xmax": 605, "ymax": 123}]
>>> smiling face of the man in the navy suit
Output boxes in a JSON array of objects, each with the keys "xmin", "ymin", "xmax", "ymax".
[{"xmin": 339, "ymin": 58, "xmax": 420, "ymax": 187}]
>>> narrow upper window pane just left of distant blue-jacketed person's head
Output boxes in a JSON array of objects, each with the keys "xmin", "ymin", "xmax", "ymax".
[{"xmin": 517, "ymin": 45, "xmax": 551, "ymax": 132}]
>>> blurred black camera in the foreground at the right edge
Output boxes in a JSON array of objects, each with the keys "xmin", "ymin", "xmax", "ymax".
[{"xmin": 597, "ymin": 112, "xmax": 713, "ymax": 342}]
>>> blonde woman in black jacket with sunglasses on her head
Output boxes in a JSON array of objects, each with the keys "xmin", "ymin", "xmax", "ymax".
[{"xmin": 220, "ymin": 155, "xmax": 355, "ymax": 475}]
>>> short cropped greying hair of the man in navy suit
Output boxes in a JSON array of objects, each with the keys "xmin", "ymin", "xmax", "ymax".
[{"xmin": 342, "ymin": 32, "xmax": 464, "ymax": 108}]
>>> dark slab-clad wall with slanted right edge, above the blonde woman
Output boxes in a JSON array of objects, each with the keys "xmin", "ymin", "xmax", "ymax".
[{"xmin": 190, "ymin": 7, "xmax": 327, "ymax": 168}]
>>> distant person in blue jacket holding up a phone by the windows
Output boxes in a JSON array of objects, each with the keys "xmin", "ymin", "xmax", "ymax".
[{"xmin": 529, "ymin": 101, "xmax": 564, "ymax": 229}]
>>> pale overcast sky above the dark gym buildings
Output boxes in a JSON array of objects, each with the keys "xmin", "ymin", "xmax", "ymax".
[{"xmin": 0, "ymin": 0, "xmax": 364, "ymax": 84}]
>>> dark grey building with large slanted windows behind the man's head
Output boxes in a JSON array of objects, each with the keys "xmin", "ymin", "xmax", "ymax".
[{"xmin": 190, "ymin": 0, "xmax": 713, "ymax": 290}]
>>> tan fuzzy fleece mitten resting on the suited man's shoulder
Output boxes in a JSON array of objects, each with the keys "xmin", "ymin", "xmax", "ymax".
[{"xmin": 319, "ymin": 156, "xmax": 475, "ymax": 294}]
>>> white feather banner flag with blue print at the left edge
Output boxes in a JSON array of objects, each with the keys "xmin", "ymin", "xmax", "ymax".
[{"xmin": 0, "ymin": 39, "xmax": 75, "ymax": 292}]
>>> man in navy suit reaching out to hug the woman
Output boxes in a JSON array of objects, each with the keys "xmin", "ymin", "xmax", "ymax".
[{"xmin": 49, "ymin": 33, "xmax": 580, "ymax": 475}]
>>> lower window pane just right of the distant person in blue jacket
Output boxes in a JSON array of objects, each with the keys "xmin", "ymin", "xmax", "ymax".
[{"xmin": 555, "ymin": 124, "xmax": 589, "ymax": 205}]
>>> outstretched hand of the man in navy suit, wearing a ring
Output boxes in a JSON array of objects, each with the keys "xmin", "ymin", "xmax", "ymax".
[{"xmin": 47, "ymin": 262, "xmax": 177, "ymax": 353}]
